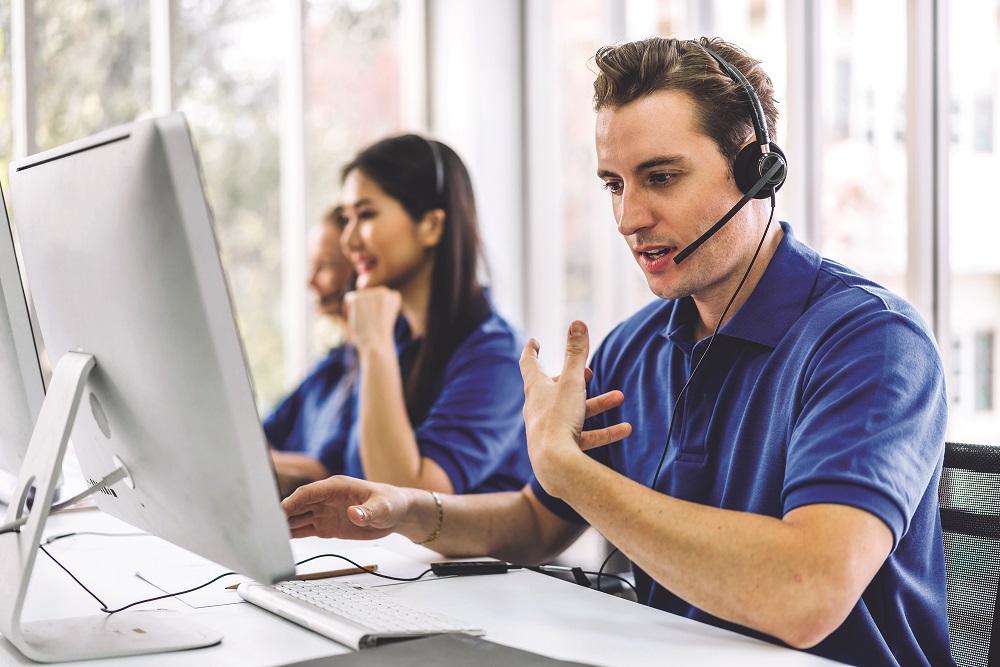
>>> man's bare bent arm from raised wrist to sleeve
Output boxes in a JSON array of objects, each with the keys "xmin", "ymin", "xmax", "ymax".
[{"xmin": 548, "ymin": 457, "xmax": 892, "ymax": 646}]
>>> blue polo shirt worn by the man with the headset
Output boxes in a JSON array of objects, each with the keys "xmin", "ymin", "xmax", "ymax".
[{"xmin": 532, "ymin": 223, "xmax": 954, "ymax": 667}]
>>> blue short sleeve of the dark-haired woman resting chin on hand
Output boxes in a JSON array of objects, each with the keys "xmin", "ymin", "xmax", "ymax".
[{"xmin": 414, "ymin": 332, "xmax": 527, "ymax": 493}]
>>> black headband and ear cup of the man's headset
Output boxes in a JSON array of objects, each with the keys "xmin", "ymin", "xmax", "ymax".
[{"xmin": 702, "ymin": 46, "xmax": 788, "ymax": 199}]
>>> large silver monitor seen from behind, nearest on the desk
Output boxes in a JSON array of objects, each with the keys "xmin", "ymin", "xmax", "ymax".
[{"xmin": 0, "ymin": 113, "xmax": 294, "ymax": 660}]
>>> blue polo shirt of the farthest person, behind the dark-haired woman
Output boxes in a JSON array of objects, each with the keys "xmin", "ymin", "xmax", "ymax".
[{"xmin": 263, "ymin": 345, "xmax": 357, "ymax": 474}]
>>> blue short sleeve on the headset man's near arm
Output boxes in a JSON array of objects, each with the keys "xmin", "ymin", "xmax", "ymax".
[{"xmin": 782, "ymin": 309, "xmax": 947, "ymax": 544}]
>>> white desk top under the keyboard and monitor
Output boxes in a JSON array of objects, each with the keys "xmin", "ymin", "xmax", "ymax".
[{"xmin": 0, "ymin": 510, "xmax": 835, "ymax": 667}]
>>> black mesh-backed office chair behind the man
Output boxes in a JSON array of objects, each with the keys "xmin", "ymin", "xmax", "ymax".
[{"xmin": 938, "ymin": 442, "xmax": 1000, "ymax": 667}]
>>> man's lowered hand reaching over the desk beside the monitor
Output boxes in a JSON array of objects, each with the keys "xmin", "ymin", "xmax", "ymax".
[{"xmin": 281, "ymin": 475, "xmax": 428, "ymax": 540}]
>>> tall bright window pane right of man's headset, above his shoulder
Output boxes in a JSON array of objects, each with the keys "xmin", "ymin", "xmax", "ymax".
[{"xmin": 820, "ymin": 0, "xmax": 909, "ymax": 296}]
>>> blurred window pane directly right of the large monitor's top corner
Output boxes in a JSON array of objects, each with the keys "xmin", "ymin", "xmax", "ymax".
[{"xmin": 174, "ymin": 0, "xmax": 284, "ymax": 406}]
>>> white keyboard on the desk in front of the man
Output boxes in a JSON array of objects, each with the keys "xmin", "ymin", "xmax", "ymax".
[{"xmin": 236, "ymin": 579, "xmax": 485, "ymax": 649}]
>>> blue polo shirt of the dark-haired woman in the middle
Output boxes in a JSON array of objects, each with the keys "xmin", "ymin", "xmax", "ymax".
[{"xmin": 343, "ymin": 309, "xmax": 531, "ymax": 493}]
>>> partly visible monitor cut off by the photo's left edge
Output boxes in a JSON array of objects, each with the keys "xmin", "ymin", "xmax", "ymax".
[{"xmin": 0, "ymin": 184, "xmax": 45, "ymax": 505}]
